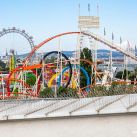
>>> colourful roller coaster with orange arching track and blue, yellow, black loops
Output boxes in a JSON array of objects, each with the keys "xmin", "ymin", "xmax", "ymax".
[{"xmin": 0, "ymin": 31, "xmax": 137, "ymax": 99}]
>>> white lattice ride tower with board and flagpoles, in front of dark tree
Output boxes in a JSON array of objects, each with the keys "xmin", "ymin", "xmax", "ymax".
[{"xmin": 77, "ymin": 4, "xmax": 100, "ymax": 88}]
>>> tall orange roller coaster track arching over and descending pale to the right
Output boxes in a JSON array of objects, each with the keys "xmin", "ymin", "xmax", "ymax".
[{"xmin": 7, "ymin": 32, "xmax": 137, "ymax": 96}]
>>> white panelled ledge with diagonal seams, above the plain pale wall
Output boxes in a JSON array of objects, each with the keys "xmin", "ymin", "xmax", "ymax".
[{"xmin": 0, "ymin": 92, "xmax": 137, "ymax": 118}]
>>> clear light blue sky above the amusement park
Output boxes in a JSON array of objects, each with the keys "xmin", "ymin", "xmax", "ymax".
[{"xmin": 0, "ymin": 0, "xmax": 137, "ymax": 55}]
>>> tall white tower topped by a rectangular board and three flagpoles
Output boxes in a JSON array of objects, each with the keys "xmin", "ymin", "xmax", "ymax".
[{"xmin": 77, "ymin": 4, "xmax": 100, "ymax": 86}]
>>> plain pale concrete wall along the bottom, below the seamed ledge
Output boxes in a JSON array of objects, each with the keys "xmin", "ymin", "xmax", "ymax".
[{"xmin": 0, "ymin": 115, "xmax": 137, "ymax": 137}]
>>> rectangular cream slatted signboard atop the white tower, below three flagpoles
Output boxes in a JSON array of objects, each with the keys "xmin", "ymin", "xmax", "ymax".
[{"xmin": 78, "ymin": 16, "xmax": 99, "ymax": 28}]
